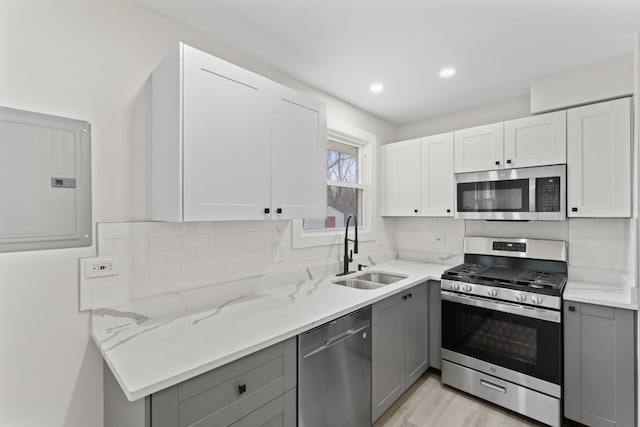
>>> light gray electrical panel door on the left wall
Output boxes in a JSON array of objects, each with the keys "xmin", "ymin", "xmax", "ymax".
[{"xmin": 0, "ymin": 108, "xmax": 91, "ymax": 252}]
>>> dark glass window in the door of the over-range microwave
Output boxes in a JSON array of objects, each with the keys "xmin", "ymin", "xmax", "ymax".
[{"xmin": 457, "ymin": 179, "xmax": 529, "ymax": 212}]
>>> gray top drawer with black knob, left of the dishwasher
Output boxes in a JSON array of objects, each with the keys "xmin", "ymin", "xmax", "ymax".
[{"xmin": 151, "ymin": 338, "xmax": 296, "ymax": 427}]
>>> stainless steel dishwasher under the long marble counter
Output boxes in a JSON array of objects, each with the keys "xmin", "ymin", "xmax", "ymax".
[{"xmin": 298, "ymin": 307, "xmax": 371, "ymax": 427}]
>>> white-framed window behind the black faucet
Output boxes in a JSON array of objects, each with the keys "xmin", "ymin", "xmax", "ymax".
[{"xmin": 292, "ymin": 121, "xmax": 375, "ymax": 248}]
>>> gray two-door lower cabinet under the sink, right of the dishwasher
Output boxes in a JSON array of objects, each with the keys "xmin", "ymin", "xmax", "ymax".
[{"xmin": 371, "ymin": 282, "xmax": 429, "ymax": 421}]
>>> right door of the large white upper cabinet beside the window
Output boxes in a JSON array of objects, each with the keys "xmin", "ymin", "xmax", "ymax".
[{"xmin": 265, "ymin": 85, "xmax": 327, "ymax": 219}]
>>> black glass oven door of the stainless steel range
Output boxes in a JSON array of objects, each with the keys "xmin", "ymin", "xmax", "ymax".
[{"xmin": 442, "ymin": 291, "xmax": 562, "ymax": 385}]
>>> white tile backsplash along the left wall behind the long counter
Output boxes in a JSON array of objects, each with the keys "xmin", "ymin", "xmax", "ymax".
[{"xmin": 80, "ymin": 220, "xmax": 396, "ymax": 309}]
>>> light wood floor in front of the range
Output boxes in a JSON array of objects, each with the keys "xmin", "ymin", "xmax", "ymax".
[{"xmin": 373, "ymin": 371, "xmax": 542, "ymax": 427}]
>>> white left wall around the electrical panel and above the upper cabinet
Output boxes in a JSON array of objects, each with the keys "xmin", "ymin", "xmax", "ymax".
[{"xmin": 0, "ymin": 0, "xmax": 396, "ymax": 427}]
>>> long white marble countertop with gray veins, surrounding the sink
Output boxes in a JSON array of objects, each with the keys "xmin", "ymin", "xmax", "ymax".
[{"xmin": 92, "ymin": 260, "xmax": 449, "ymax": 401}]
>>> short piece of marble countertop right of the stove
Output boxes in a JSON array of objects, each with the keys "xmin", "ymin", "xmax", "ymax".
[{"xmin": 562, "ymin": 280, "xmax": 638, "ymax": 310}]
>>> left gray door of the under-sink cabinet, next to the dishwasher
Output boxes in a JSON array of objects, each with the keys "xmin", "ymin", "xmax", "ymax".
[{"xmin": 371, "ymin": 295, "xmax": 405, "ymax": 421}]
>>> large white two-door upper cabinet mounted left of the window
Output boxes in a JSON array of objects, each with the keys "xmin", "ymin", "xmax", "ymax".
[{"xmin": 152, "ymin": 43, "xmax": 326, "ymax": 221}]
